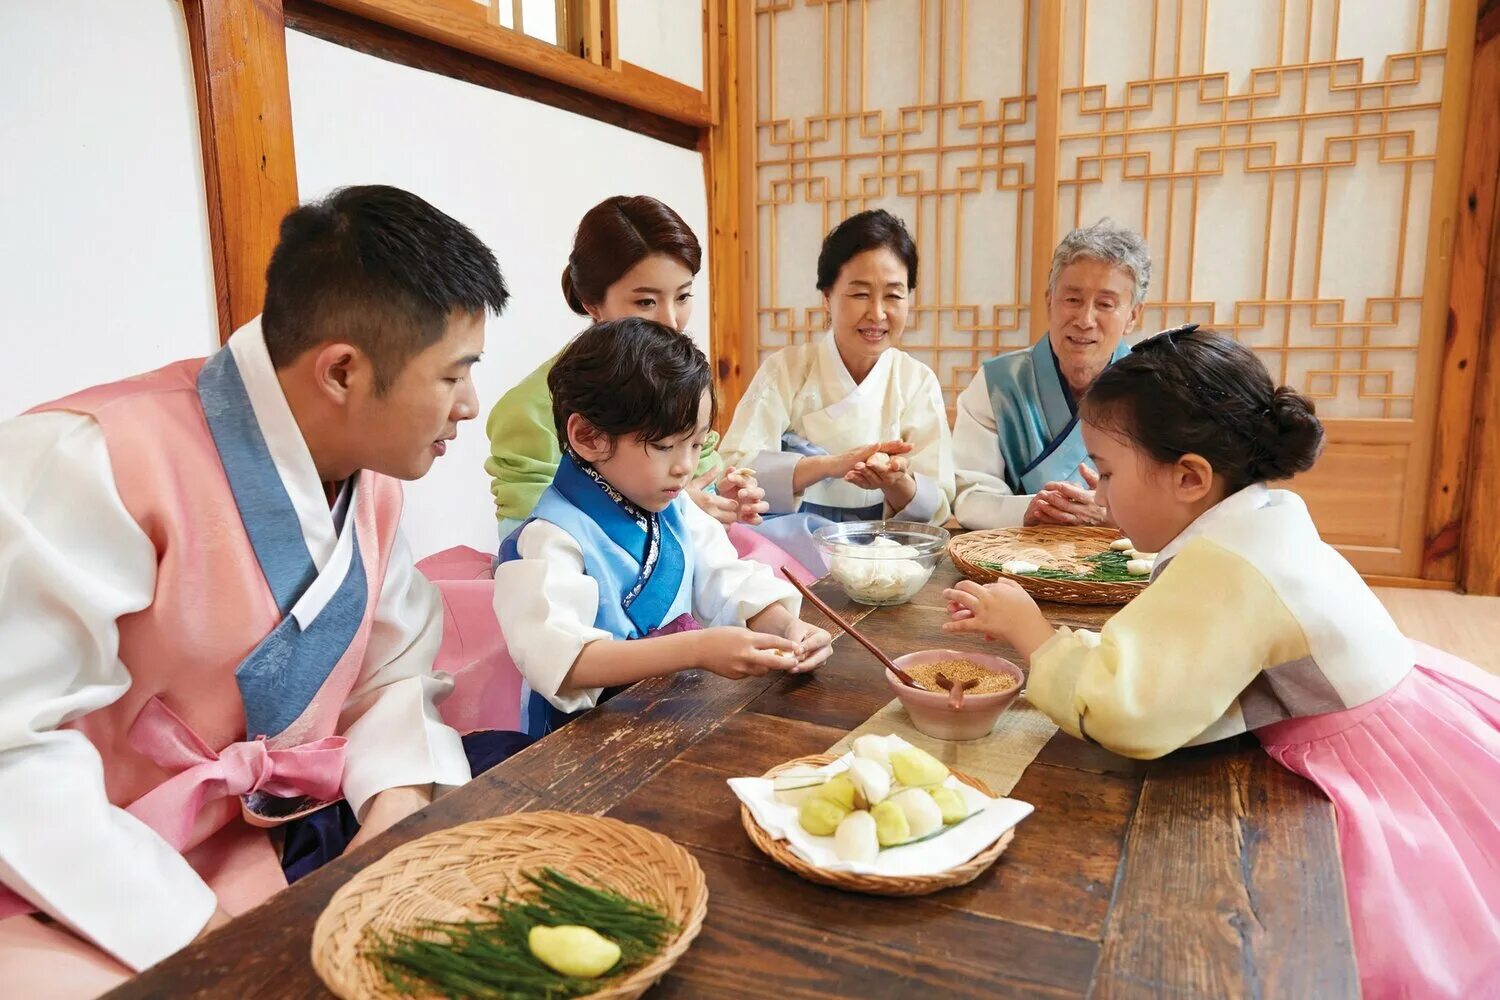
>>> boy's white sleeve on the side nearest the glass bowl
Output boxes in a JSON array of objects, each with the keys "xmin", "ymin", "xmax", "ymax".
[{"xmin": 678, "ymin": 501, "xmax": 803, "ymax": 627}]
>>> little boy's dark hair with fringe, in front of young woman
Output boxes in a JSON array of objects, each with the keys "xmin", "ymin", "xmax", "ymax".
[{"xmin": 548, "ymin": 316, "xmax": 719, "ymax": 444}]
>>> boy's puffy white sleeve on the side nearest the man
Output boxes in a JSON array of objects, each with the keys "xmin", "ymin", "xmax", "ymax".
[{"xmin": 495, "ymin": 514, "xmax": 609, "ymax": 712}]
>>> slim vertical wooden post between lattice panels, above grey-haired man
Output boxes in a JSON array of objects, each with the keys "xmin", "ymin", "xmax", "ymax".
[{"xmin": 1031, "ymin": 0, "xmax": 1064, "ymax": 343}]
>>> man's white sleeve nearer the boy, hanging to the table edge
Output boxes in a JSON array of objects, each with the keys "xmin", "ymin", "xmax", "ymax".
[{"xmin": 339, "ymin": 534, "xmax": 470, "ymax": 820}]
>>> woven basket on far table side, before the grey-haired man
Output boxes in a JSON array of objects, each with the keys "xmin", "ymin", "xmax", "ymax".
[{"xmin": 948, "ymin": 526, "xmax": 1146, "ymax": 604}]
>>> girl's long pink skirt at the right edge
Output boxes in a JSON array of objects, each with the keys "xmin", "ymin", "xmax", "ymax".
[{"xmin": 1256, "ymin": 643, "xmax": 1500, "ymax": 1000}]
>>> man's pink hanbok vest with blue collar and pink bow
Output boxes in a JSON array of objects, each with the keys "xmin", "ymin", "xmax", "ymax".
[{"xmin": 0, "ymin": 349, "xmax": 402, "ymax": 996}]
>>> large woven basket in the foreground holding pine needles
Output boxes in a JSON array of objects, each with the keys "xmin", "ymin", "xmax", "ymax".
[{"xmin": 312, "ymin": 813, "xmax": 708, "ymax": 1000}]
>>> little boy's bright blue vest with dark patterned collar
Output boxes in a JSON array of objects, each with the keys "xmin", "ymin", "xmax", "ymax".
[{"xmin": 500, "ymin": 454, "xmax": 695, "ymax": 739}]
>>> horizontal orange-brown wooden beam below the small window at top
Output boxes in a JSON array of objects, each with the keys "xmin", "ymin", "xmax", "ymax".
[{"xmin": 312, "ymin": 0, "xmax": 710, "ymax": 127}]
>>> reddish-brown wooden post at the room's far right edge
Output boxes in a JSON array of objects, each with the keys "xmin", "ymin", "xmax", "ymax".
[{"xmin": 1458, "ymin": 3, "xmax": 1500, "ymax": 595}]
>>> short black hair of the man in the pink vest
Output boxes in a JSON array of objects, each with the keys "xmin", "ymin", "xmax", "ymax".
[{"xmin": 261, "ymin": 184, "xmax": 510, "ymax": 393}]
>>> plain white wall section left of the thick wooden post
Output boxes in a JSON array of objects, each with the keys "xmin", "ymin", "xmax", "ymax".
[{"xmin": 0, "ymin": 0, "xmax": 219, "ymax": 418}]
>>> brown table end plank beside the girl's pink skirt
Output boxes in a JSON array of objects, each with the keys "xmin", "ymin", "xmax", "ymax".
[{"xmin": 1094, "ymin": 738, "xmax": 1359, "ymax": 999}]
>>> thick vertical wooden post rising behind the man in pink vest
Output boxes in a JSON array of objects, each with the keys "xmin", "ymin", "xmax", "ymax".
[{"xmin": 183, "ymin": 0, "xmax": 297, "ymax": 340}]
